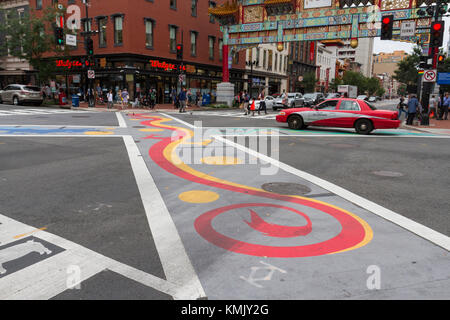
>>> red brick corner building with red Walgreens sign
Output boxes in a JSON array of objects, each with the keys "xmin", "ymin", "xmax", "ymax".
[{"xmin": 30, "ymin": 0, "xmax": 245, "ymax": 103}]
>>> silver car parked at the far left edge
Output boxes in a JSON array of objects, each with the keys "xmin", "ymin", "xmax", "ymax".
[{"xmin": 0, "ymin": 84, "xmax": 44, "ymax": 106}]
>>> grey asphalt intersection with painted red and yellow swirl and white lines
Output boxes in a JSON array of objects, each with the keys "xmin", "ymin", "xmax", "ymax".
[{"xmin": 0, "ymin": 106, "xmax": 450, "ymax": 300}]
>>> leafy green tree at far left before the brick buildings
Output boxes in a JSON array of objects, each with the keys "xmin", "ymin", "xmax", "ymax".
[{"xmin": 0, "ymin": 6, "xmax": 70, "ymax": 81}]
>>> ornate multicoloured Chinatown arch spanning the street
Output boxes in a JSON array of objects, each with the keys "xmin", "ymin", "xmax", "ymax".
[{"xmin": 209, "ymin": 0, "xmax": 433, "ymax": 101}]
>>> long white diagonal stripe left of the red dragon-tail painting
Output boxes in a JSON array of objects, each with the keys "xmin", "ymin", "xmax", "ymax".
[{"xmin": 123, "ymin": 136, "xmax": 206, "ymax": 298}]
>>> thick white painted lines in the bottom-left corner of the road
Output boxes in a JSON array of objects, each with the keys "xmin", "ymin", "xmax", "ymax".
[{"xmin": 0, "ymin": 215, "xmax": 190, "ymax": 300}]
